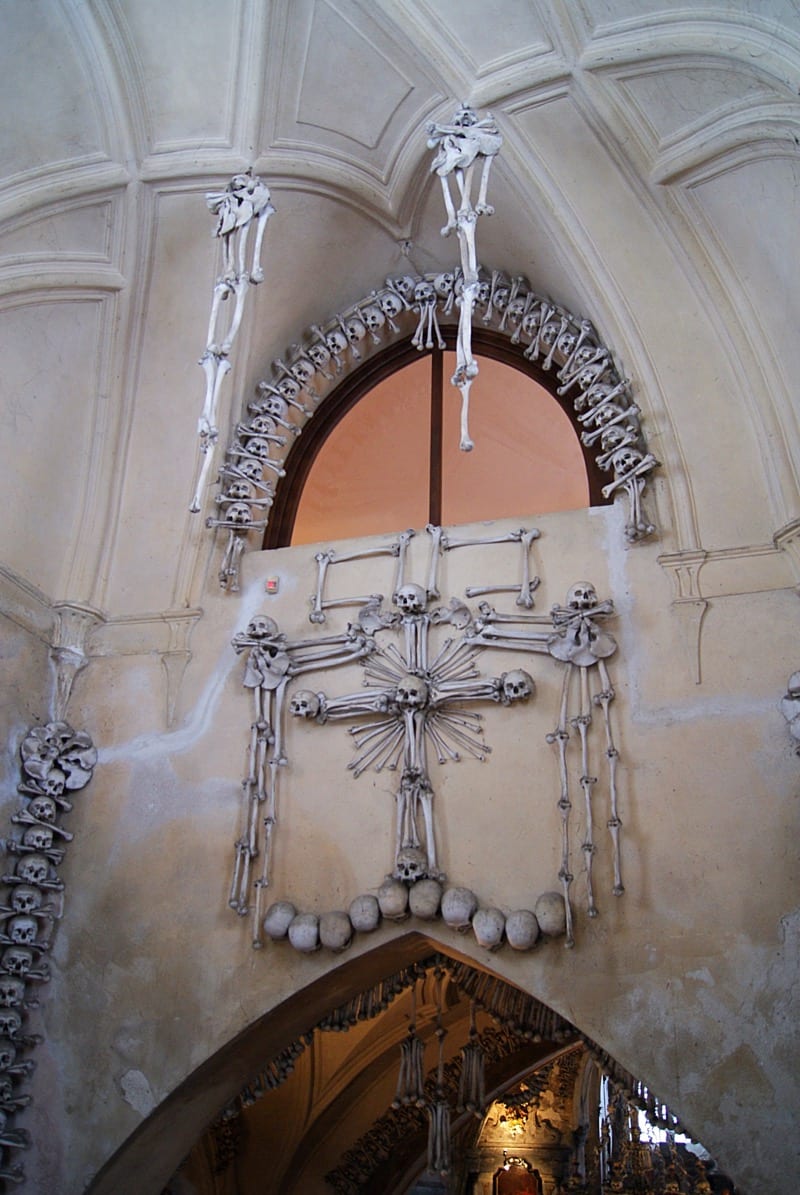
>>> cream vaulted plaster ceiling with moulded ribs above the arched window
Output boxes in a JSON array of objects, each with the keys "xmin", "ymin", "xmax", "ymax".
[{"xmin": 0, "ymin": 0, "xmax": 800, "ymax": 615}]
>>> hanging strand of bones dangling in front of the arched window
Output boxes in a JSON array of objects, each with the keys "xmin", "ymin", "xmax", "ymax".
[{"xmin": 417, "ymin": 104, "xmax": 502, "ymax": 452}]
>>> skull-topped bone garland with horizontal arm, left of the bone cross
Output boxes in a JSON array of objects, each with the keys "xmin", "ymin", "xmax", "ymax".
[{"xmin": 228, "ymin": 614, "xmax": 372, "ymax": 948}]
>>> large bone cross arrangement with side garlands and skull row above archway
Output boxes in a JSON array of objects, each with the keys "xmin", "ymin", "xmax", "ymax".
[{"xmin": 230, "ymin": 526, "xmax": 623, "ymax": 951}]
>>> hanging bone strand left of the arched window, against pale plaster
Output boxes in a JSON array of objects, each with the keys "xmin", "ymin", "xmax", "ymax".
[{"xmin": 189, "ymin": 171, "xmax": 275, "ymax": 514}]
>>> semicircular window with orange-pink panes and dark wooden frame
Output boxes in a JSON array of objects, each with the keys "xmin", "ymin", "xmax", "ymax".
[{"xmin": 264, "ymin": 330, "xmax": 607, "ymax": 547}]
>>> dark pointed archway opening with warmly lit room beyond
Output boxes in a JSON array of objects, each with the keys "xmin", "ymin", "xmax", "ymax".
[{"xmin": 91, "ymin": 933, "xmax": 732, "ymax": 1195}]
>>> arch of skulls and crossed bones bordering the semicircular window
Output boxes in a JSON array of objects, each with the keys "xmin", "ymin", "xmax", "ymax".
[{"xmin": 206, "ymin": 265, "xmax": 659, "ymax": 593}]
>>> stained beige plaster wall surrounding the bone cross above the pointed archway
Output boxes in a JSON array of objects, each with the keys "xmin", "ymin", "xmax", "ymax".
[{"xmin": 6, "ymin": 508, "xmax": 800, "ymax": 1195}]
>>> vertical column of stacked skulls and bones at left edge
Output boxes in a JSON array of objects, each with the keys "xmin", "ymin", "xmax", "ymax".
[{"xmin": 0, "ymin": 722, "xmax": 97, "ymax": 1183}]
